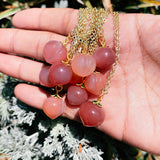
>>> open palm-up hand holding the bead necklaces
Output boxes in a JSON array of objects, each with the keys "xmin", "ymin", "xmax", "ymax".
[{"xmin": 0, "ymin": 9, "xmax": 160, "ymax": 154}]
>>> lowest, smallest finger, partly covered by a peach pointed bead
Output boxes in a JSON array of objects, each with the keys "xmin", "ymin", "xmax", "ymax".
[{"xmin": 14, "ymin": 84, "xmax": 78, "ymax": 120}]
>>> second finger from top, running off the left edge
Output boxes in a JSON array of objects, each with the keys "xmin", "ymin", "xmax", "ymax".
[{"xmin": 0, "ymin": 29, "xmax": 65, "ymax": 60}]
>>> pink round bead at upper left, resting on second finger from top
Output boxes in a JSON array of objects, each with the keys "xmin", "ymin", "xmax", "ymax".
[{"xmin": 43, "ymin": 41, "xmax": 67, "ymax": 64}]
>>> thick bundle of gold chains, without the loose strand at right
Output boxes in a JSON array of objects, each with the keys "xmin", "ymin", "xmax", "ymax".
[{"xmin": 63, "ymin": 8, "xmax": 110, "ymax": 63}]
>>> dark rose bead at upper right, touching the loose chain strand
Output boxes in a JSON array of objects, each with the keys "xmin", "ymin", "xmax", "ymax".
[{"xmin": 93, "ymin": 47, "xmax": 116, "ymax": 69}]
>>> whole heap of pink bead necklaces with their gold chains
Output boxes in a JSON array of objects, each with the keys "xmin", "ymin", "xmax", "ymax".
[{"xmin": 40, "ymin": 8, "xmax": 119, "ymax": 127}]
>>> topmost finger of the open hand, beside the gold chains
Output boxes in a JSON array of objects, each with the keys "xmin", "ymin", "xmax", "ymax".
[{"xmin": 12, "ymin": 8, "xmax": 78, "ymax": 35}]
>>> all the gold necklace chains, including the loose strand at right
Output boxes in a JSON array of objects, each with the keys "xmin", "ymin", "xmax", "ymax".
[{"xmin": 63, "ymin": 8, "xmax": 120, "ymax": 106}]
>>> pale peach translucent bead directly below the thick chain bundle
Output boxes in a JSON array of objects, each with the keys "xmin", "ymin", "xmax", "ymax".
[{"xmin": 71, "ymin": 54, "xmax": 96, "ymax": 77}]
